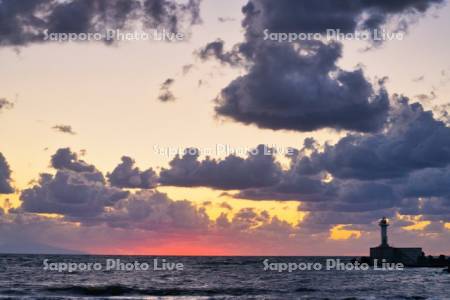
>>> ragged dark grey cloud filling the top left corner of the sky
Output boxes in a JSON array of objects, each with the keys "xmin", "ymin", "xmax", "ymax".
[{"xmin": 0, "ymin": 0, "xmax": 200, "ymax": 46}]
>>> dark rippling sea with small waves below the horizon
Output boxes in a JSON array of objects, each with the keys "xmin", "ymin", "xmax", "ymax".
[{"xmin": 0, "ymin": 254, "xmax": 450, "ymax": 299}]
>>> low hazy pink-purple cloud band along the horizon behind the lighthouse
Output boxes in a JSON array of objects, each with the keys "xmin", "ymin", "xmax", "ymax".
[{"xmin": 4, "ymin": 206, "xmax": 450, "ymax": 256}]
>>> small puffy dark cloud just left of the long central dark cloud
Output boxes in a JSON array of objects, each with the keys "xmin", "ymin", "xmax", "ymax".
[{"xmin": 106, "ymin": 156, "xmax": 158, "ymax": 189}]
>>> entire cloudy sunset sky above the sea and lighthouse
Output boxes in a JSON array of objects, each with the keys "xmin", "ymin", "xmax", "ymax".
[{"xmin": 0, "ymin": 0, "xmax": 450, "ymax": 255}]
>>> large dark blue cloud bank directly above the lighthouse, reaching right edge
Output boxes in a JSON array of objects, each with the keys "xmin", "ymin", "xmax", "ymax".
[{"xmin": 222, "ymin": 96, "xmax": 450, "ymax": 226}]
